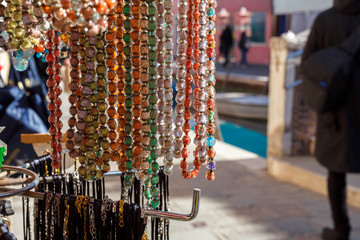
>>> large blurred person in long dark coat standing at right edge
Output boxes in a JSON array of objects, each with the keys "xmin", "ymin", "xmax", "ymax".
[{"xmin": 302, "ymin": 0, "xmax": 360, "ymax": 240}]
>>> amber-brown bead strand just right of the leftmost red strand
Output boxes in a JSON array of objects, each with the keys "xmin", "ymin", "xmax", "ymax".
[{"xmin": 66, "ymin": 27, "xmax": 80, "ymax": 162}]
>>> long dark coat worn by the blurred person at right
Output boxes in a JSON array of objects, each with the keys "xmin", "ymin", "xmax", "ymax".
[{"xmin": 303, "ymin": 0, "xmax": 360, "ymax": 172}]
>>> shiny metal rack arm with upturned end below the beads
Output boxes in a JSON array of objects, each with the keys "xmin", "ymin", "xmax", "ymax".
[{"xmin": 145, "ymin": 188, "xmax": 201, "ymax": 222}]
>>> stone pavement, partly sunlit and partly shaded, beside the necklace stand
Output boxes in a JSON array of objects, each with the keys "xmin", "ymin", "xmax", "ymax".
[{"xmin": 165, "ymin": 143, "xmax": 360, "ymax": 240}]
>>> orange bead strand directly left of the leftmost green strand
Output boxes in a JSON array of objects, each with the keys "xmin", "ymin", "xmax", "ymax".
[{"xmin": 116, "ymin": 0, "xmax": 126, "ymax": 172}]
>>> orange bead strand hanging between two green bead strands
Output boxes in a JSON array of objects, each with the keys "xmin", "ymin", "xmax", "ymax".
[{"xmin": 131, "ymin": 0, "xmax": 142, "ymax": 170}]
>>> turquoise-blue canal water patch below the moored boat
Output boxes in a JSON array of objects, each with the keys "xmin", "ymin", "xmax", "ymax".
[{"xmin": 220, "ymin": 122, "xmax": 267, "ymax": 158}]
